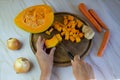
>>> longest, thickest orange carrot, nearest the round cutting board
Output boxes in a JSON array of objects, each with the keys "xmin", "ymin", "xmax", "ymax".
[{"xmin": 78, "ymin": 3, "xmax": 102, "ymax": 32}]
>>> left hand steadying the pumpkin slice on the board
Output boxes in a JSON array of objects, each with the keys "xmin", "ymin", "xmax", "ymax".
[{"xmin": 35, "ymin": 36, "xmax": 56, "ymax": 80}]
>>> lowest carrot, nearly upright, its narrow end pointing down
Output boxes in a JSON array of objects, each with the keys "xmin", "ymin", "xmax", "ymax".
[{"xmin": 97, "ymin": 30, "xmax": 110, "ymax": 57}]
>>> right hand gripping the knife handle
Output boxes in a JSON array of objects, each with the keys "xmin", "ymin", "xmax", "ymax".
[{"xmin": 71, "ymin": 55, "xmax": 94, "ymax": 80}]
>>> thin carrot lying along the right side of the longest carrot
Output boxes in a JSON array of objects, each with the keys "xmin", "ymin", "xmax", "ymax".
[{"xmin": 88, "ymin": 9, "xmax": 108, "ymax": 30}]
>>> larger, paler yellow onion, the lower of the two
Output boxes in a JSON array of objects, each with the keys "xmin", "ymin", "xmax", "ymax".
[{"xmin": 14, "ymin": 57, "xmax": 31, "ymax": 73}]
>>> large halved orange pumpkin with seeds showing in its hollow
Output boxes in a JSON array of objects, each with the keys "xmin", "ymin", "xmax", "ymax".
[{"xmin": 14, "ymin": 5, "xmax": 54, "ymax": 33}]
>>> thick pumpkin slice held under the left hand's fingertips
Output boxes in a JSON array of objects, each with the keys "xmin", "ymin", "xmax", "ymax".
[{"xmin": 45, "ymin": 34, "xmax": 62, "ymax": 48}]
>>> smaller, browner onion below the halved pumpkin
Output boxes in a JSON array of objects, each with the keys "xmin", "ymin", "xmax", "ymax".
[{"xmin": 7, "ymin": 38, "xmax": 21, "ymax": 50}]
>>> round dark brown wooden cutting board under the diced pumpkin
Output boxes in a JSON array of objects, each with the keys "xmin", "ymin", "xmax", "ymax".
[{"xmin": 30, "ymin": 12, "xmax": 93, "ymax": 66}]
